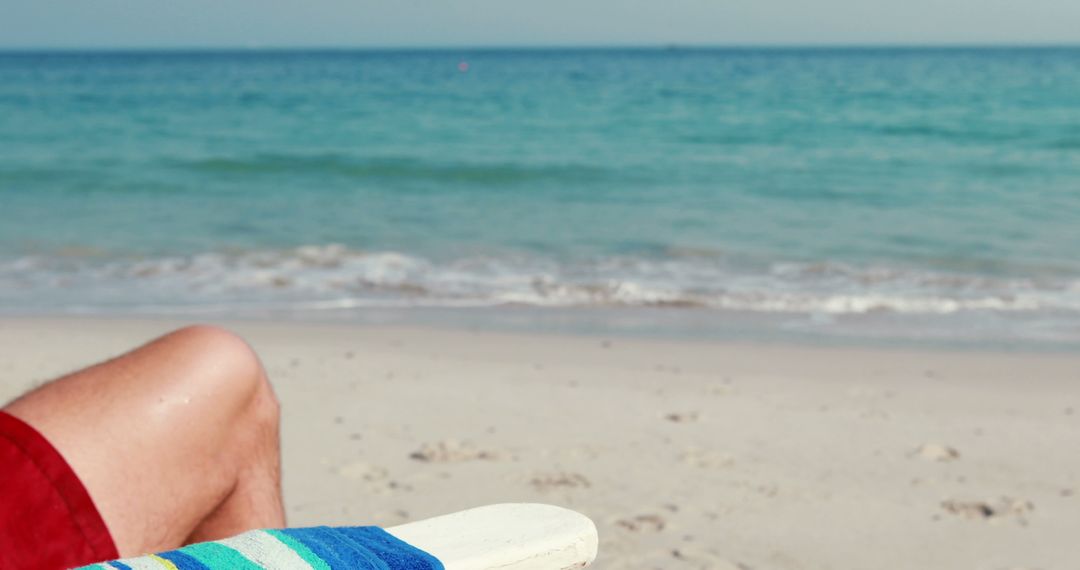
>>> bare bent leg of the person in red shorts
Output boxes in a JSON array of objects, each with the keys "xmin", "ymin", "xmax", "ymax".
[{"xmin": 4, "ymin": 326, "xmax": 284, "ymax": 556}]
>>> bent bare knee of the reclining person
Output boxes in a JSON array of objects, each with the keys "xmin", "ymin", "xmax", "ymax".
[{"xmin": 163, "ymin": 325, "xmax": 279, "ymax": 422}]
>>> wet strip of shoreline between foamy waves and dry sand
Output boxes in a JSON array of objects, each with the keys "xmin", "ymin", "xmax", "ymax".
[{"xmin": 0, "ymin": 306, "xmax": 1080, "ymax": 355}]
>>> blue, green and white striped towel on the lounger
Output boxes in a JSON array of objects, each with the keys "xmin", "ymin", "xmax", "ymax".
[{"xmin": 79, "ymin": 527, "xmax": 443, "ymax": 570}]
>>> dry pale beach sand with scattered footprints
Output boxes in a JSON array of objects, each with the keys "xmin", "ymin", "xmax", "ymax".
[{"xmin": 0, "ymin": 318, "xmax": 1080, "ymax": 570}]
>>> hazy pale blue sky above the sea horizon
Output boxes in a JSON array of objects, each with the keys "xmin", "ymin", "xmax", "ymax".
[{"xmin": 0, "ymin": 0, "xmax": 1080, "ymax": 49}]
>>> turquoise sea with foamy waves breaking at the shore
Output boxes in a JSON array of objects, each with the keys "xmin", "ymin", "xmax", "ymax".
[{"xmin": 0, "ymin": 49, "xmax": 1080, "ymax": 344}]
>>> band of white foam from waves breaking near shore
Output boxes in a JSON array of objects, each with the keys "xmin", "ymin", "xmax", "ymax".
[{"xmin": 0, "ymin": 244, "xmax": 1080, "ymax": 315}]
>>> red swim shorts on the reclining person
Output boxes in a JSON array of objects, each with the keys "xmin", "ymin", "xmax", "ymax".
[{"xmin": 0, "ymin": 411, "xmax": 119, "ymax": 570}]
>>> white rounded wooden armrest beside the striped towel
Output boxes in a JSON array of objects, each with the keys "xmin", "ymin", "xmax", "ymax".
[{"xmin": 386, "ymin": 503, "xmax": 597, "ymax": 570}]
